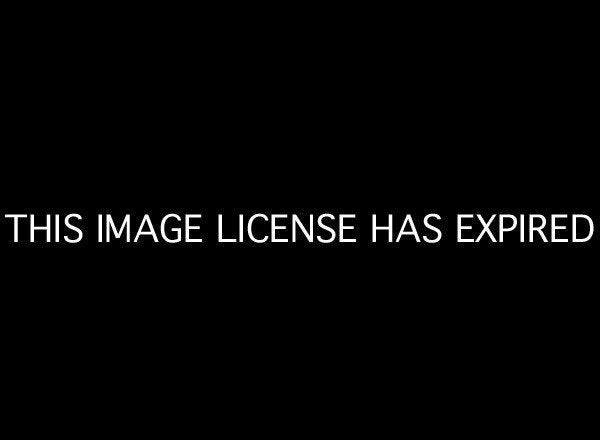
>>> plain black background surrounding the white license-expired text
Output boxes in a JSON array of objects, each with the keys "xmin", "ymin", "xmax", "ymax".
[{"xmin": 1, "ymin": 5, "xmax": 598, "ymax": 433}]
